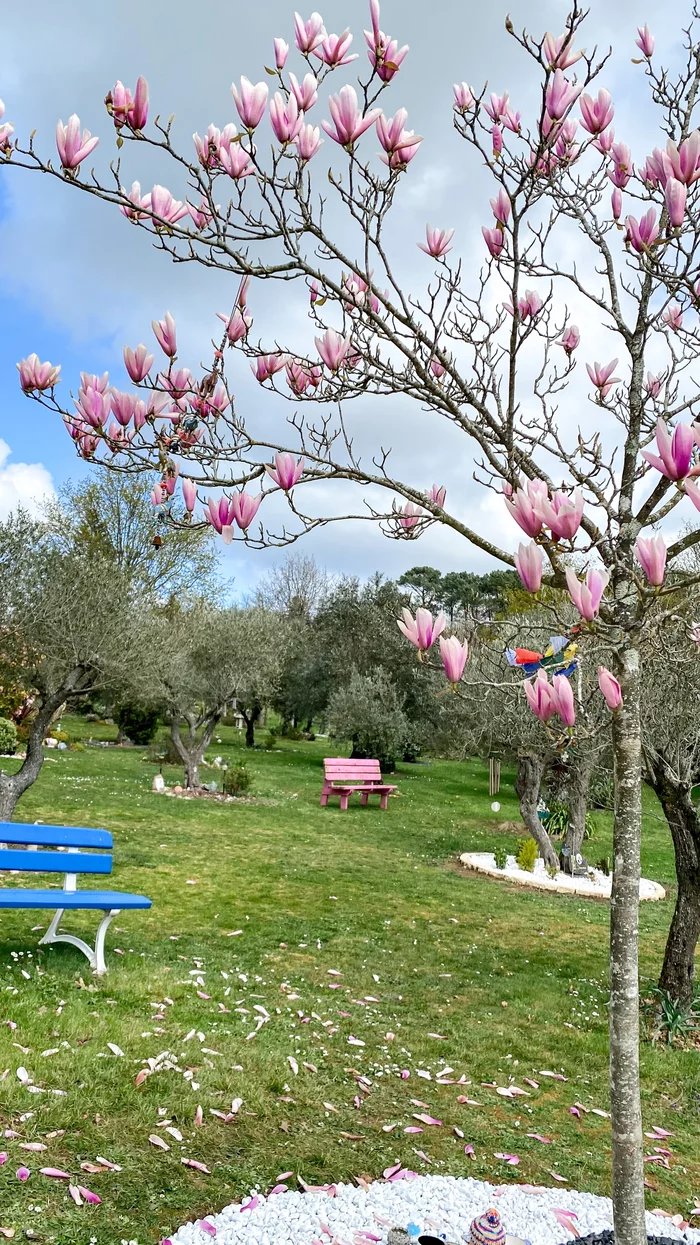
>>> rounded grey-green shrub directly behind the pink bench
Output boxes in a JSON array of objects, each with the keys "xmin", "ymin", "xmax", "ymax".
[{"xmin": 328, "ymin": 669, "xmax": 412, "ymax": 771}]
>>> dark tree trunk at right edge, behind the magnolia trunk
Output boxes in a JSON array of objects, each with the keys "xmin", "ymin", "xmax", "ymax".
[{"xmin": 646, "ymin": 753, "xmax": 700, "ymax": 1003}]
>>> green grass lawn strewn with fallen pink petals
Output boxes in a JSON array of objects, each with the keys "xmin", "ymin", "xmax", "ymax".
[{"xmin": 0, "ymin": 720, "xmax": 700, "ymax": 1245}]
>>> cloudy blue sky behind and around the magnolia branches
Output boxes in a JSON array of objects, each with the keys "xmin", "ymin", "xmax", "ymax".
[{"xmin": 0, "ymin": 0, "xmax": 688, "ymax": 589}]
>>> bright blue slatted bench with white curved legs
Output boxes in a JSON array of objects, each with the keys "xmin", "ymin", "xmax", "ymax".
[{"xmin": 0, "ymin": 822, "xmax": 151, "ymax": 974}]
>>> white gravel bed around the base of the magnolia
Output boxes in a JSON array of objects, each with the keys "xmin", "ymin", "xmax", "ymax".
[{"xmin": 163, "ymin": 1175, "xmax": 700, "ymax": 1245}]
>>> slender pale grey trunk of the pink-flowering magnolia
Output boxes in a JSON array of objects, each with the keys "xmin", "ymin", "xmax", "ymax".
[{"xmin": 610, "ymin": 645, "xmax": 646, "ymax": 1245}]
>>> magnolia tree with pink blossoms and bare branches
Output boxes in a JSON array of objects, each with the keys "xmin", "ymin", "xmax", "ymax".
[{"xmin": 6, "ymin": 0, "xmax": 700, "ymax": 1245}]
